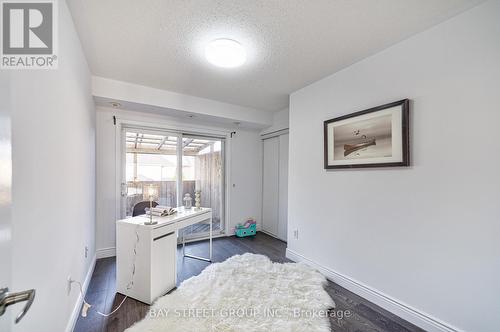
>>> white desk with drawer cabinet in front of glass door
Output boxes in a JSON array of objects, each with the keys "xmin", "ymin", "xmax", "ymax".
[{"xmin": 116, "ymin": 207, "xmax": 212, "ymax": 304}]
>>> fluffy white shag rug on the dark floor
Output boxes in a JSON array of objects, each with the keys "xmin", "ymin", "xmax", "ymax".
[{"xmin": 126, "ymin": 254, "xmax": 335, "ymax": 332}]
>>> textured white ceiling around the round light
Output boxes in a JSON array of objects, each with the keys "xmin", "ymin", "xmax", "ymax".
[{"xmin": 68, "ymin": 0, "xmax": 482, "ymax": 111}]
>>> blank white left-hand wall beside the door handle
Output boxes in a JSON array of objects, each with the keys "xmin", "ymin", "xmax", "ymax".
[{"xmin": 9, "ymin": 1, "xmax": 95, "ymax": 332}]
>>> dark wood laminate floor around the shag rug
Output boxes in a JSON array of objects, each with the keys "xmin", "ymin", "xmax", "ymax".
[{"xmin": 74, "ymin": 233, "xmax": 423, "ymax": 332}]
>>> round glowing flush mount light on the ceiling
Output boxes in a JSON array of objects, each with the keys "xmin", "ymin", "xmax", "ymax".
[{"xmin": 205, "ymin": 39, "xmax": 247, "ymax": 68}]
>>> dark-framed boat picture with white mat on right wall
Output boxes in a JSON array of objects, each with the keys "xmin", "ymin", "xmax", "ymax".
[{"xmin": 324, "ymin": 99, "xmax": 410, "ymax": 169}]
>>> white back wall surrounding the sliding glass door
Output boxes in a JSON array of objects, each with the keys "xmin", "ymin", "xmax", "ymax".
[{"xmin": 96, "ymin": 107, "xmax": 262, "ymax": 257}]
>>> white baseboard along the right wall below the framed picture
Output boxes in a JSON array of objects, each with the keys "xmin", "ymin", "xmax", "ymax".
[{"xmin": 286, "ymin": 248, "xmax": 463, "ymax": 332}]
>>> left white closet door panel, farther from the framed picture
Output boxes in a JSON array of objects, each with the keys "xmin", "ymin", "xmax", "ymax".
[{"xmin": 262, "ymin": 137, "xmax": 280, "ymax": 236}]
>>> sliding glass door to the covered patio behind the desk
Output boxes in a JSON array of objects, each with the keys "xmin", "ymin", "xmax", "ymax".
[{"xmin": 120, "ymin": 128, "xmax": 225, "ymax": 238}]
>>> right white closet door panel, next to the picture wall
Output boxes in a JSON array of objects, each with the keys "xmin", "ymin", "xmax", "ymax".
[{"xmin": 277, "ymin": 134, "xmax": 288, "ymax": 241}]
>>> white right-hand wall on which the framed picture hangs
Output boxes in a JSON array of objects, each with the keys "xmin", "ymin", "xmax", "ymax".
[{"xmin": 288, "ymin": 1, "xmax": 500, "ymax": 332}]
